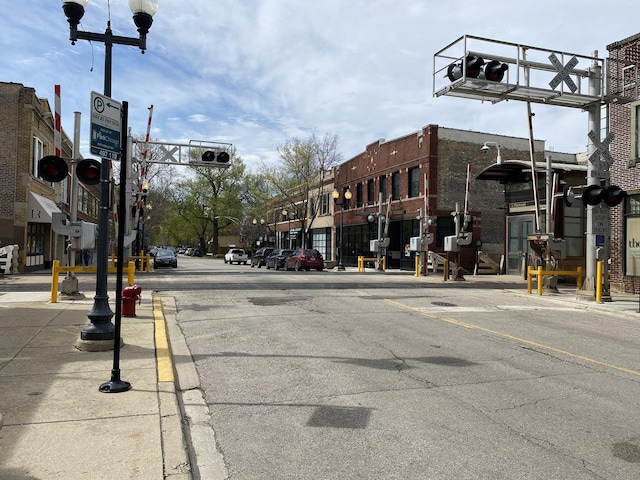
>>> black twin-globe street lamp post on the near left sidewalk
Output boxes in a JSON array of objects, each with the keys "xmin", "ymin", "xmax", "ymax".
[{"xmin": 62, "ymin": 0, "xmax": 158, "ymax": 351}]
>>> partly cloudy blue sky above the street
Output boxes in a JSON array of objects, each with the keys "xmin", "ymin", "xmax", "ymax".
[{"xmin": 5, "ymin": 0, "xmax": 640, "ymax": 170}]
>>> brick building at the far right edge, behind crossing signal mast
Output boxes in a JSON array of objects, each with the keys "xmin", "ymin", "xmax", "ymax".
[{"xmin": 607, "ymin": 34, "xmax": 640, "ymax": 293}]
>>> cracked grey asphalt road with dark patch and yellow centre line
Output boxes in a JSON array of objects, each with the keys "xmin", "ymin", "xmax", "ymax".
[{"xmin": 155, "ymin": 257, "xmax": 640, "ymax": 480}]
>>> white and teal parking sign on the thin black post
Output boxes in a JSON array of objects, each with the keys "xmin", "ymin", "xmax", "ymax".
[{"xmin": 91, "ymin": 92, "xmax": 122, "ymax": 161}]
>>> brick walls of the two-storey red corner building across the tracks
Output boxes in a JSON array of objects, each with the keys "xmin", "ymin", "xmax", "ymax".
[{"xmin": 335, "ymin": 125, "xmax": 544, "ymax": 253}]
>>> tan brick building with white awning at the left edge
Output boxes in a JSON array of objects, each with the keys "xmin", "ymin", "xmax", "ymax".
[{"xmin": 0, "ymin": 82, "xmax": 98, "ymax": 271}]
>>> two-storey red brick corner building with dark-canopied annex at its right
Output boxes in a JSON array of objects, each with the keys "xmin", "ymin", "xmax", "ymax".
[{"xmin": 334, "ymin": 125, "xmax": 586, "ymax": 274}]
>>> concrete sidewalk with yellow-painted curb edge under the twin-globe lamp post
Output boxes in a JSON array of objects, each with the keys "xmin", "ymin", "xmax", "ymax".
[{"xmin": 0, "ymin": 292, "xmax": 191, "ymax": 480}]
